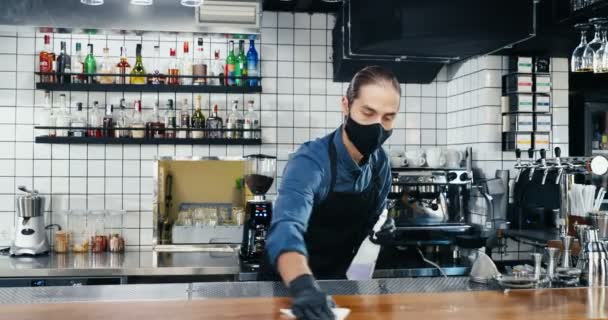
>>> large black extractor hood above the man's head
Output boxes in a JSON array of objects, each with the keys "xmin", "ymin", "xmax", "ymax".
[{"xmin": 333, "ymin": 0, "xmax": 549, "ymax": 83}]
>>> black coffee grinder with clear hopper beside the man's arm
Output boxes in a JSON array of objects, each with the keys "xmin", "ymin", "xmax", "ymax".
[{"xmin": 241, "ymin": 154, "xmax": 276, "ymax": 265}]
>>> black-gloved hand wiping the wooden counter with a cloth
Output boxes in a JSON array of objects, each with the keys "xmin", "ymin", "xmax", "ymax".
[{"xmin": 289, "ymin": 274, "xmax": 336, "ymax": 320}]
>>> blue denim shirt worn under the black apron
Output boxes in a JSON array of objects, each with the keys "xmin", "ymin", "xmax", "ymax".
[{"xmin": 266, "ymin": 127, "xmax": 391, "ymax": 265}]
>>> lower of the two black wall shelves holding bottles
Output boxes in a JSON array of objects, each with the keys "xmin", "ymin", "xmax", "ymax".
[{"xmin": 35, "ymin": 136, "xmax": 262, "ymax": 145}]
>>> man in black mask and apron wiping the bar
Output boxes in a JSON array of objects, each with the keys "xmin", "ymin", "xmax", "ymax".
[{"xmin": 261, "ymin": 66, "xmax": 401, "ymax": 319}]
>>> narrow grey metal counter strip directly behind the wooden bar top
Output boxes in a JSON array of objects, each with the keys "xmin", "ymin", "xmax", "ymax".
[{"xmin": 0, "ymin": 277, "xmax": 494, "ymax": 304}]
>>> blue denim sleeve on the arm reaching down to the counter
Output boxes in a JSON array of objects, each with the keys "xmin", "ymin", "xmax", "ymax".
[{"xmin": 266, "ymin": 152, "xmax": 323, "ymax": 266}]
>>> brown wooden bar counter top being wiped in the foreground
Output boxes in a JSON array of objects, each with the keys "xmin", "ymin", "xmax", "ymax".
[{"xmin": 0, "ymin": 288, "xmax": 608, "ymax": 320}]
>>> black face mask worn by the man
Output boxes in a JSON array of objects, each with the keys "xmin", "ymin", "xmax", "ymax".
[{"xmin": 344, "ymin": 116, "xmax": 393, "ymax": 158}]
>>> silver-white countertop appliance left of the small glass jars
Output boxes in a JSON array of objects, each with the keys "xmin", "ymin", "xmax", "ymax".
[{"xmin": 10, "ymin": 186, "xmax": 49, "ymax": 256}]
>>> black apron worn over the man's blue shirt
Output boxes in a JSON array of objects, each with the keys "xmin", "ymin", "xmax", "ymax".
[{"xmin": 258, "ymin": 132, "xmax": 381, "ymax": 281}]
